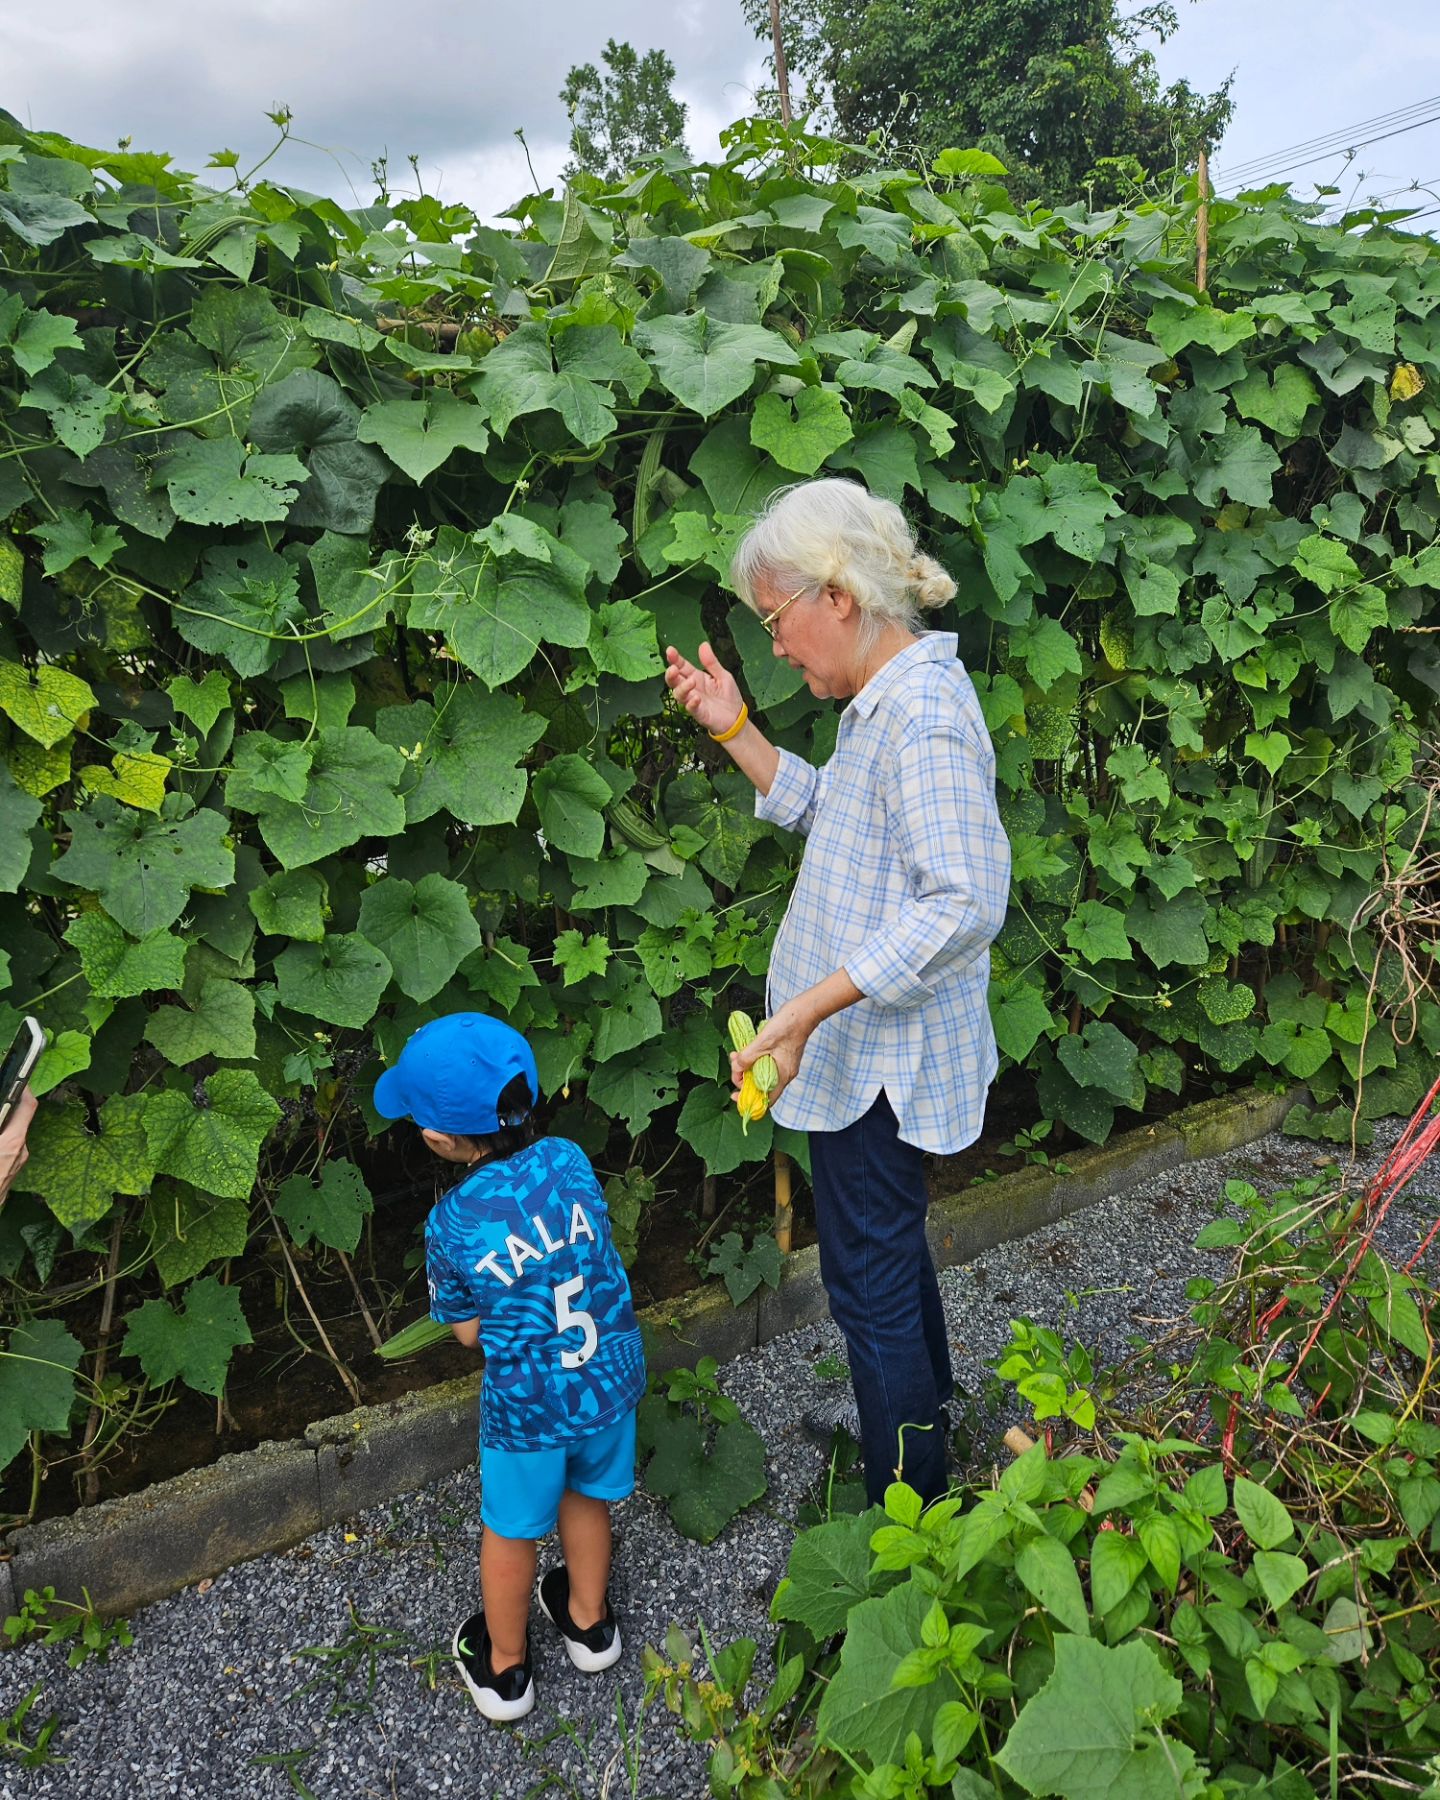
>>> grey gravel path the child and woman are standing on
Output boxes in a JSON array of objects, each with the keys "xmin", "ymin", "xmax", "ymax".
[{"xmin": 0, "ymin": 1123, "xmax": 1440, "ymax": 1800}]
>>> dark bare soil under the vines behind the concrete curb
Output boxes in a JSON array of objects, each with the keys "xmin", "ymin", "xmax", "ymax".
[{"xmin": 0, "ymin": 1071, "xmax": 1216, "ymax": 1528}]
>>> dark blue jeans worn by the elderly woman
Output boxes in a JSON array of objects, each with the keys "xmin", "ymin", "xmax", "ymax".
[{"xmin": 810, "ymin": 1093, "xmax": 954, "ymax": 1501}]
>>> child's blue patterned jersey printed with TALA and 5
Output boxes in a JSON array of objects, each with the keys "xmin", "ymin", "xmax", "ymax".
[{"xmin": 425, "ymin": 1138, "xmax": 644, "ymax": 1451}]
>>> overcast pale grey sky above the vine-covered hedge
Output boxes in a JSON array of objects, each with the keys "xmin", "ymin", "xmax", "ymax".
[{"xmin": 0, "ymin": 0, "xmax": 1440, "ymax": 223}]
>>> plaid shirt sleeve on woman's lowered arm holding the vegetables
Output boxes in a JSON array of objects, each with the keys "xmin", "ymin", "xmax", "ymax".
[{"xmin": 846, "ymin": 731, "xmax": 1010, "ymax": 1008}]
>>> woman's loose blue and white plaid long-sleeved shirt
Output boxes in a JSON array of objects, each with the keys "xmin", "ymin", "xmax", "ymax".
[{"xmin": 756, "ymin": 632, "xmax": 1010, "ymax": 1152}]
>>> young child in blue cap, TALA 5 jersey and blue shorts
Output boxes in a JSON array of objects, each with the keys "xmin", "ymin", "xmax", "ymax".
[{"xmin": 374, "ymin": 1013, "xmax": 644, "ymax": 1721}]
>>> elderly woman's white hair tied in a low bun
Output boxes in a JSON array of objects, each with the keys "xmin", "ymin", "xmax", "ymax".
[{"xmin": 731, "ymin": 475, "xmax": 956, "ymax": 653}]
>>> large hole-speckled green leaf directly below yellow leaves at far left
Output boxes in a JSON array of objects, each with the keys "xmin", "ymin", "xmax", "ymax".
[{"xmin": 52, "ymin": 796, "xmax": 236, "ymax": 938}]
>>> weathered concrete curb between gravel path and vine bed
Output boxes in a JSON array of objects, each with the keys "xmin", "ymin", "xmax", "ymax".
[{"xmin": 0, "ymin": 1087, "xmax": 1300, "ymax": 1616}]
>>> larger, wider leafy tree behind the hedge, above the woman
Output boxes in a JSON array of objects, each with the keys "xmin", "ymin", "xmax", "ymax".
[{"xmin": 742, "ymin": 0, "xmax": 1233, "ymax": 200}]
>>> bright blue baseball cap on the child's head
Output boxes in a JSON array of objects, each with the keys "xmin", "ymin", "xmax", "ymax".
[{"xmin": 374, "ymin": 1013, "xmax": 540, "ymax": 1138}]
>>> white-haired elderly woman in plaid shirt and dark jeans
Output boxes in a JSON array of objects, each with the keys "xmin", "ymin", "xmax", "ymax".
[{"xmin": 666, "ymin": 481, "xmax": 1010, "ymax": 1501}]
